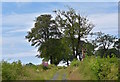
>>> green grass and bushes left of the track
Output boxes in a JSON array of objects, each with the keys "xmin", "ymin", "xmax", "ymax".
[{"xmin": 2, "ymin": 61, "xmax": 58, "ymax": 80}]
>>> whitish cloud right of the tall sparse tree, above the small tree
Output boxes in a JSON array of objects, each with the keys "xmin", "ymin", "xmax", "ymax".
[{"xmin": 89, "ymin": 13, "xmax": 118, "ymax": 35}]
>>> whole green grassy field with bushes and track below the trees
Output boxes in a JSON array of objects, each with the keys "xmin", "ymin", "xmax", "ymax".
[{"xmin": 2, "ymin": 56, "xmax": 120, "ymax": 80}]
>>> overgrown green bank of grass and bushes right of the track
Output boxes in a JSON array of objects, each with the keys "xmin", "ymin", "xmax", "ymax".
[{"xmin": 67, "ymin": 56, "xmax": 119, "ymax": 80}]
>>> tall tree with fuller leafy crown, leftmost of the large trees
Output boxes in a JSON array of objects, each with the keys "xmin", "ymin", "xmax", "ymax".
[{"xmin": 26, "ymin": 14, "xmax": 61, "ymax": 64}]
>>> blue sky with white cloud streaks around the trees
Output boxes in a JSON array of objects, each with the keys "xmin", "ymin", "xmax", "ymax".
[{"xmin": 0, "ymin": 0, "xmax": 118, "ymax": 64}]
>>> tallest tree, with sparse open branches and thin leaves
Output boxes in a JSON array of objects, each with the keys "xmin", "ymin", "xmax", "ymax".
[{"xmin": 54, "ymin": 8, "xmax": 94, "ymax": 58}]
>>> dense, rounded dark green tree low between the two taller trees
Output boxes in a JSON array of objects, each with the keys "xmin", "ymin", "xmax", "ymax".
[{"xmin": 38, "ymin": 39, "xmax": 66, "ymax": 65}]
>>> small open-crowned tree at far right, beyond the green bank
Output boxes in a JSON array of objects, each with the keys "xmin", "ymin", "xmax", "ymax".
[{"xmin": 92, "ymin": 32, "xmax": 116, "ymax": 57}]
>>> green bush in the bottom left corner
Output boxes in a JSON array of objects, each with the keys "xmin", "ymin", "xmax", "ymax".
[{"xmin": 2, "ymin": 61, "xmax": 24, "ymax": 80}]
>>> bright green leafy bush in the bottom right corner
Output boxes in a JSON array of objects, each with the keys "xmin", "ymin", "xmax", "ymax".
[{"xmin": 91, "ymin": 56, "xmax": 118, "ymax": 80}]
